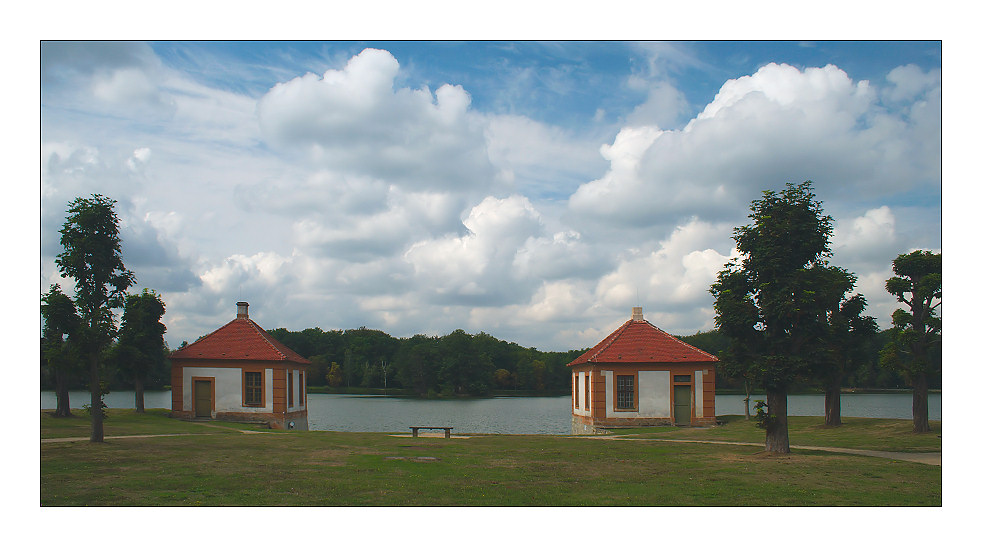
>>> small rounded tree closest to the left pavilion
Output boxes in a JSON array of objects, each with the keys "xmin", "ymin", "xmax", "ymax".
[{"xmin": 115, "ymin": 289, "xmax": 167, "ymax": 412}]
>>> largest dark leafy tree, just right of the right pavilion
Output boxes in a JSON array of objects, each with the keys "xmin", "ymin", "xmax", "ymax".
[{"xmin": 710, "ymin": 181, "xmax": 832, "ymax": 453}]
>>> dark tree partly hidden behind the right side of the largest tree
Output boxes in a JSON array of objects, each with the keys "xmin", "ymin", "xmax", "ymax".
[{"xmin": 816, "ymin": 288, "xmax": 877, "ymax": 426}]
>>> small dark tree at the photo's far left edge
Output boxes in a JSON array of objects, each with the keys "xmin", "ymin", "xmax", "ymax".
[{"xmin": 41, "ymin": 284, "xmax": 79, "ymax": 418}]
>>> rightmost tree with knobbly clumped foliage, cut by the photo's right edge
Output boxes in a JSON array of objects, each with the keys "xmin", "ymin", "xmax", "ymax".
[{"xmin": 880, "ymin": 251, "xmax": 941, "ymax": 433}]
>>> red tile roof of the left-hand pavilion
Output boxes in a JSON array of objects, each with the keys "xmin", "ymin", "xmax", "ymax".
[{"xmin": 170, "ymin": 317, "xmax": 310, "ymax": 364}]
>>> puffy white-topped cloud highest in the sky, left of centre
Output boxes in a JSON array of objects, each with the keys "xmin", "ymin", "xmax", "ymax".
[{"xmin": 258, "ymin": 49, "xmax": 493, "ymax": 191}]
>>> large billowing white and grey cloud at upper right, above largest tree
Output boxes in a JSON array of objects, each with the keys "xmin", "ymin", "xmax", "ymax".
[{"xmin": 570, "ymin": 64, "xmax": 939, "ymax": 232}]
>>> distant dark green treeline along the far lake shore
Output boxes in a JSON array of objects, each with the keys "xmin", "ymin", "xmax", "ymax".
[{"xmin": 41, "ymin": 327, "xmax": 941, "ymax": 397}]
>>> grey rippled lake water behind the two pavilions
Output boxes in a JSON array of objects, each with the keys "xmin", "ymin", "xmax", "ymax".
[{"xmin": 41, "ymin": 391, "xmax": 941, "ymax": 435}]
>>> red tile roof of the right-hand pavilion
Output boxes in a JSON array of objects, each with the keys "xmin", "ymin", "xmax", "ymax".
[{"xmin": 566, "ymin": 319, "xmax": 719, "ymax": 366}]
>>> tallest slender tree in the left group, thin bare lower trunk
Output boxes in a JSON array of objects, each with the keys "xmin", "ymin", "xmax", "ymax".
[{"xmin": 55, "ymin": 194, "xmax": 134, "ymax": 442}]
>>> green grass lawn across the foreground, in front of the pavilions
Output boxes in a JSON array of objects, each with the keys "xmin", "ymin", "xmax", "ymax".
[{"xmin": 41, "ymin": 410, "xmax": 941, "ymax": 506}]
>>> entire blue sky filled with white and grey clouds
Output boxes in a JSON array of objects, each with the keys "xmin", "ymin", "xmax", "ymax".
[{"xmin": 40, "ymin": 41, "xmax": 941, "ymax": 351}]
